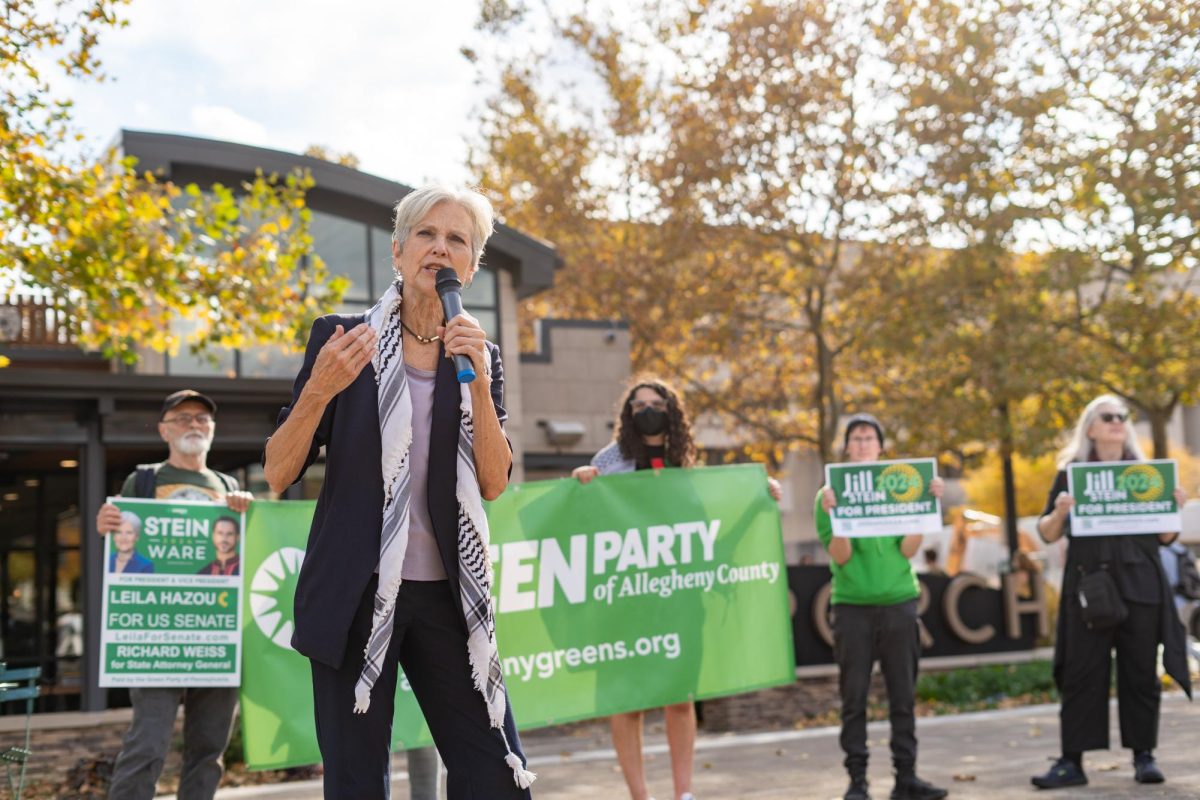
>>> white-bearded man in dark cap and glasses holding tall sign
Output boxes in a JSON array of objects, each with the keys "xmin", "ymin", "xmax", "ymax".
[{"xmin": 96, "ymin": 389, "xmax": 251, "ymax": 800}]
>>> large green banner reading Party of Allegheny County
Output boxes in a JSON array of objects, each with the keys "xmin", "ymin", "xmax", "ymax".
[{"xmin": 242, "ymin": 465, "xmax": 796, "ymax": 769}]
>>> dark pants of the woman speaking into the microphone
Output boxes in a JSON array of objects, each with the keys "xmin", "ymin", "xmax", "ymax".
[{"xmin": 310, "ymin": 581, "xmax": 530, "ymax": 800}]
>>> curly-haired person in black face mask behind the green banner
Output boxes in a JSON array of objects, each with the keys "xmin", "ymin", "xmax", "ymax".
[{"xmin": 571, "ymin": 378, "xmax": 782, "ymax": 800}]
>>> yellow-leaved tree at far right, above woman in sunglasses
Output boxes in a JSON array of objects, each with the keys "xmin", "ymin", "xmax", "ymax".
[{"xmin": 1030, "ymin": 0, "xmax": 1200, "ymax": 457}]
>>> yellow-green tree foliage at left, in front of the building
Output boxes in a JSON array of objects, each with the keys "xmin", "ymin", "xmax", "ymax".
[{"xmin": 0, "ymin": 0, "xmax": 344, "ymax": 360}]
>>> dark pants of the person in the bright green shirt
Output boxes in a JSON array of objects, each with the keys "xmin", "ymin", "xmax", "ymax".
[{"xmin": 833, "ymin": 600, "xmax": 920, "ymax": 775}]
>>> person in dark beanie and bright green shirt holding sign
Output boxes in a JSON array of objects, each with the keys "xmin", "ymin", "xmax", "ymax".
[{"xmin": 812, "ymin": 414, "xmax": 947, "ymax": 800}]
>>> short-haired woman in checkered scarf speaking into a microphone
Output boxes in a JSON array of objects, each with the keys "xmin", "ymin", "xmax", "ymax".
[{"xmin": 270, "ymin": 186, "xmax": 534, "ymax": 800}]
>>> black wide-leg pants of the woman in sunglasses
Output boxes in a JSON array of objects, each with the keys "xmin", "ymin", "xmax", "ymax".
[{"xmin": 1058, "ymin": 595, "xmax": 1163, "ymax": 753}]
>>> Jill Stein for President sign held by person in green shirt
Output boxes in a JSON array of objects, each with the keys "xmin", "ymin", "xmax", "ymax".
[{"xmin": 826, "ymin": 458, "xmax": 942, "ymax": 537}]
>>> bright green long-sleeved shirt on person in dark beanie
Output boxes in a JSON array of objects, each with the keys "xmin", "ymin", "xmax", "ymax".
[{"xmin": 812, "ymin": 487, "xmax": 920, "ymax": 606}]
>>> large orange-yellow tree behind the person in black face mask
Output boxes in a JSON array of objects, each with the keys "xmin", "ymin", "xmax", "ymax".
[{"xmin": 474, "ymin": 1, "xmax": 921, "ymax": 458}]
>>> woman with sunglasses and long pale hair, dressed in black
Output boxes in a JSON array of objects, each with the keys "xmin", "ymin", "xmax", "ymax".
[{"xmin": 1032, "ymin": 395, "xmax": 1190, "ymax": 789}]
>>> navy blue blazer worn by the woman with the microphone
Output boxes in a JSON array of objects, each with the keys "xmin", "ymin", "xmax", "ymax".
[{"xmin": 264, "ymin": 314, "xmax": 508, "ymax": 669}]
